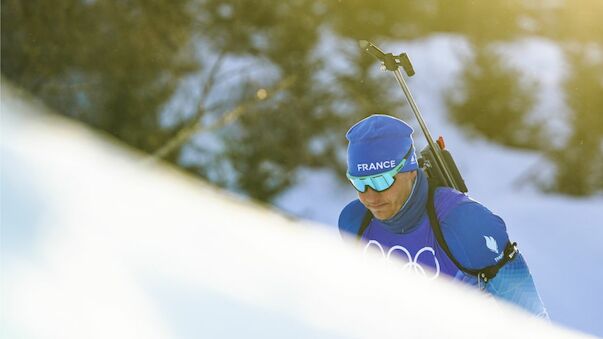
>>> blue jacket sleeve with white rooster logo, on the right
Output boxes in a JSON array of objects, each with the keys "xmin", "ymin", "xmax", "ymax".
[{"xmin": 441, "ymin": 200, "xmax": 548, "ymax": 318}]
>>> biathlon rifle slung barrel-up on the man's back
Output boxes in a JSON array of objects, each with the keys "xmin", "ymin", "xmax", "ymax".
[{"xmin": 358, "ymin": 40, "xmax": 466, "ymax": 191}]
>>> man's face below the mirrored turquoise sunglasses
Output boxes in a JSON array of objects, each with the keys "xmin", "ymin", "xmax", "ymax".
[{"xmin": 358, "ymin": 171, "xmax": 417, "ymax": 220}]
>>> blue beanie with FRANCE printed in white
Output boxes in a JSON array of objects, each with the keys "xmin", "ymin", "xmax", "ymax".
[{"xmin": 346, "ymin": 114, "xmax": 419, "ymax": 177}]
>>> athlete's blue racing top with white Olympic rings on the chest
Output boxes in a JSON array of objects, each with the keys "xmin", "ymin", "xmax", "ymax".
[{"xmin": 339, "ymin": 170, "xmax": 548, "ymax": 318}]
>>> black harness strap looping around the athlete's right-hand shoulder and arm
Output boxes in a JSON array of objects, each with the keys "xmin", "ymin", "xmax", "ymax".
[{"xmin": 427, "ymin": 181, "xmax": 517, "ymax": 282}]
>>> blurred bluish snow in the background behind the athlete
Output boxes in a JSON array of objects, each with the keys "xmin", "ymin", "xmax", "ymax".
[{"xmin": 275, "ymin": 35, "xmax": 603, "ymax": 336}]
